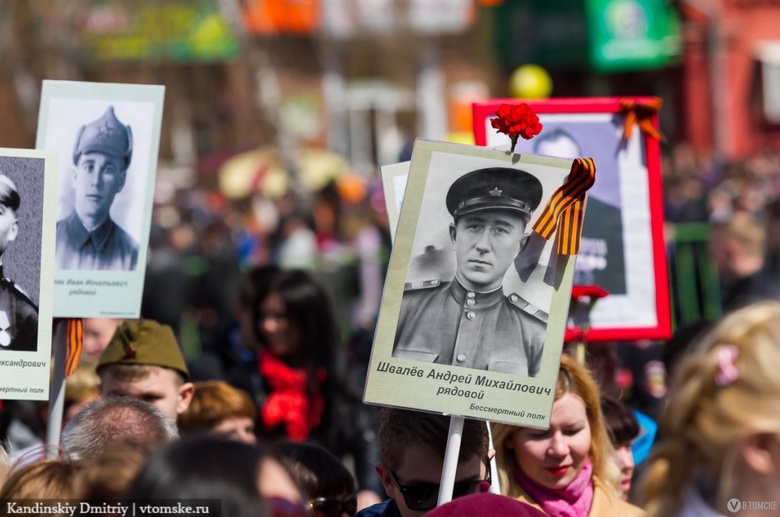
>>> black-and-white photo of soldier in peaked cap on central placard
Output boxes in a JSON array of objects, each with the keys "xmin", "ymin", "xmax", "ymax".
[{"xmin": 384, "ymin": 141, "xmax": 580, "ymax": 377}]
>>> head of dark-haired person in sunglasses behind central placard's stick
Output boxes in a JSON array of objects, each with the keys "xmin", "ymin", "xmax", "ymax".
[{"xmin": 376, "ymin": 408, "xmax": 490, "ymax": 517}]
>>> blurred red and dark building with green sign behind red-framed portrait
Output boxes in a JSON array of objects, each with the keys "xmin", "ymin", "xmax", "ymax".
[{"xmin": 492, "ymin": 0, "xmax": 780, "ymax": 159}]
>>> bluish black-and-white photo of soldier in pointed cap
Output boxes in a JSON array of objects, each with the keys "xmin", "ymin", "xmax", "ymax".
[{"xmin": 50, "ymin": 100, "xmax": 153, "ymax": 271}]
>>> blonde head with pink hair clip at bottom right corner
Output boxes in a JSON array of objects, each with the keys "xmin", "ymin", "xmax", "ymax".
[{"xmin": 639, "ymin": 301, "xmax": 780, "ymax": 515}]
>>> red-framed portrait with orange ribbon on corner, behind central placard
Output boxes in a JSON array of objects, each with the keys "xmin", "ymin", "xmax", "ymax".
[{"xmin": 473, "ymin": 97, "xmax": 672, "ymax": 341}]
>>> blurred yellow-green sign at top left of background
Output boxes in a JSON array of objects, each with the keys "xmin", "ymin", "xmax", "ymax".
[{"xmin": 79, "ymin": 0, "xmax": 238, "ymax": 62}]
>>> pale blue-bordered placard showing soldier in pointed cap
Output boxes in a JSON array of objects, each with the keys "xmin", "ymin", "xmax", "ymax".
[{"xmin": 36, "ymin": 81, "xmax": 165, "ymax": 318}]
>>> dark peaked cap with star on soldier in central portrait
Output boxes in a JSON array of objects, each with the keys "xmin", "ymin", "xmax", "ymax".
[{"xmin": 447, "ymin": 167, "xmax": 542, "ymax": 218}]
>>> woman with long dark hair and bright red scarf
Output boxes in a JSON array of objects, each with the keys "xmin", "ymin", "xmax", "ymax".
[{"xmin": 254, "ymin": 270, "xmax": 382, "ymax": 504}]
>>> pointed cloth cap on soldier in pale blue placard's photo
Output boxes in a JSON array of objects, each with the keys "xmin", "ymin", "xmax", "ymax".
[{"xmin": 73, "ymin": 106, "xmax": 133, "ymax": 166}]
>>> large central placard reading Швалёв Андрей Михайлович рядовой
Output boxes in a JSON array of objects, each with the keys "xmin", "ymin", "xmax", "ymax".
[{"xmin": 364, "ymin": 139, "xmax": 575, "ymax": 428}]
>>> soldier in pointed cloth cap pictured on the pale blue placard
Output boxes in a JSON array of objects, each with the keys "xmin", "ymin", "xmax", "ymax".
[{"xmin": 55, "ymin": 106, "xmax": 138, "ymax": 270}]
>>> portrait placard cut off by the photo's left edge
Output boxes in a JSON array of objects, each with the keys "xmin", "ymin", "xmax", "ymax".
[{"xmin": 0, "ymin": 149, "xmax": 57, "ymax": 400}]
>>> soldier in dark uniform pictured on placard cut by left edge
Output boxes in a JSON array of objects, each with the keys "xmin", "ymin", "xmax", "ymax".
[{"xmin": 0, "ymin": 173, "xmax": 38, "ymax": 351}]
